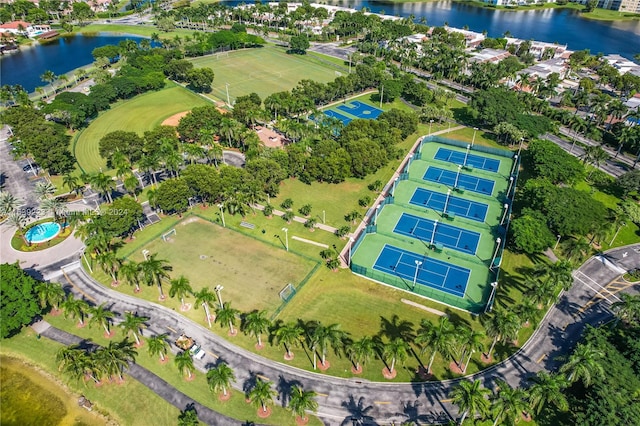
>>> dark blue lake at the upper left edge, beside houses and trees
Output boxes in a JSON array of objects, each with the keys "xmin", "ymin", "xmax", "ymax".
[{"xmin": 0, "ymin": 34, "xmax": 148, "ymax": 92}]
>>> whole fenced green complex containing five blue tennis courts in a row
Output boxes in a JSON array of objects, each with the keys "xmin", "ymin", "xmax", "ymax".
[{"xmin": 351, "ymin": 138, "xmax": 515, "ymax": 312}]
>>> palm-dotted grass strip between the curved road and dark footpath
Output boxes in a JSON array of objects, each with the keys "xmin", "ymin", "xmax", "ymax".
[{"xmin": 43, "ymin": 316, "xmax": 321, "ymax": 426}]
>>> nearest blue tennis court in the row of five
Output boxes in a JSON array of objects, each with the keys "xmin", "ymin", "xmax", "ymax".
[{"xmin": 373, "ymin": 244, "xmax": 471, "ymax": 297}]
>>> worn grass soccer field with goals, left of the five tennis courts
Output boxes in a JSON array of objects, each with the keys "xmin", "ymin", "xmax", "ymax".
[{"xmin": 130, "ymin": 217, "xmax": 315, "ymax": 314}]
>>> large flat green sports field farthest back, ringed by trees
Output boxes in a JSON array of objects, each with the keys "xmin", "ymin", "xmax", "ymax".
[{"xmin": 191, "ymin": 46, "xmax": 345, "ymax": 102}]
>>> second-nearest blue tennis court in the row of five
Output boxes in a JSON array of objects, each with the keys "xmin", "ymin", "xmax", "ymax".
[{"xmin": 393, "ymin": 213, "xmax": 480, "ymax": 254}]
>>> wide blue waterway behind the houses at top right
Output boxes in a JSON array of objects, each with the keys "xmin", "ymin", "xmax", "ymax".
[{"xmin": 224, "ymin": 0, "xmax": 640, "ymax": 58}]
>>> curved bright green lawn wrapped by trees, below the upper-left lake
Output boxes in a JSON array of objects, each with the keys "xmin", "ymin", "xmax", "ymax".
[{"xmin": 73, "ymin": 83, "xmax": 207, "ymax": 173}]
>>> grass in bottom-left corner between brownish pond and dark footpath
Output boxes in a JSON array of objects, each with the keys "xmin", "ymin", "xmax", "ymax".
[{"xmin": 0, "ymin": 326, "xmax": 179, "ymax": 426}]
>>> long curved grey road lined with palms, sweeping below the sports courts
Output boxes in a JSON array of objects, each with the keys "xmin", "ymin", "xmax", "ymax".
[{"xmin": 31, "ymin": 244, "xmax": 640, "ymax": 425}]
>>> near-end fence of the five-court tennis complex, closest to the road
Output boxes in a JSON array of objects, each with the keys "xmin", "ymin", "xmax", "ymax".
[{"xmin": 351, "ymin": 263, "xmax": 485, "ymax": 314}]
